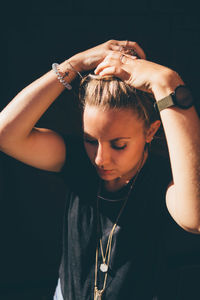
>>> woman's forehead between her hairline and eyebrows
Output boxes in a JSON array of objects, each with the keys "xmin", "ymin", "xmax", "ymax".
[{"xmin": 83, "ymin": 105, "xmax": 144, "ymax": 139}]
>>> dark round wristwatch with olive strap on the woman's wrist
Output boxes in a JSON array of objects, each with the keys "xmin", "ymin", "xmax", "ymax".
[{"xmin": 156, "ymin": 85, "xmax": 194, "ymax": 111}]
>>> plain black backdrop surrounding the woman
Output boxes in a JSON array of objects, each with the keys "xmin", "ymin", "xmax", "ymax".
[{"xmin": 0, "ymin": 0, "xmax": 200, "ymax": 300}]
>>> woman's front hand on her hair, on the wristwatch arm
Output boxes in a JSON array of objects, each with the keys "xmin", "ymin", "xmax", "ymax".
[{"xmin": 95, "ymin": 51, "xmax": 183, "ymax": 99}]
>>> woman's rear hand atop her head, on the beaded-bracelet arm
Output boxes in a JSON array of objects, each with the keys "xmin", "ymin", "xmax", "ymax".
[{"xmin": 70, "ymin": 40, "xmax": 145, "ymax": 72}]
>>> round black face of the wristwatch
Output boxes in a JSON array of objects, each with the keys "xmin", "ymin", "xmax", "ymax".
[{"xmin": 173, "ymin": 86, "xmax": 193, "ymax": 109}]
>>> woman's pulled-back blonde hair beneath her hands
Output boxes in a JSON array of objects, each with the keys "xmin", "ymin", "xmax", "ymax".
[{"xmin": 79, "ymin": 74, "xmax": 159, "ymax": 128}]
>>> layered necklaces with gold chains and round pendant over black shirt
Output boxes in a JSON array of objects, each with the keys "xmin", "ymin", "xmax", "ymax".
[{"xmin": 94, "ymin": 153, "xmax": 144, "ymax": 300}]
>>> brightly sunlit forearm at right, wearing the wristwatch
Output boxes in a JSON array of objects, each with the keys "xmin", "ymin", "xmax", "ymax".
[{"xmin": 152, "ymin": 72, "xmax": 200, "ymax": 231}]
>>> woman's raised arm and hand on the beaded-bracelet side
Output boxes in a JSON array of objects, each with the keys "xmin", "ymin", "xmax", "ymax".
[{"xmin": 0, "ymin": 40, "xmax": 134, "ymax": 172}]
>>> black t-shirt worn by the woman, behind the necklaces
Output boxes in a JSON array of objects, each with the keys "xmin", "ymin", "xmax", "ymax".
[{"xmin": 59, "ymin": 138, "xmax": 171, "ymax": 300}]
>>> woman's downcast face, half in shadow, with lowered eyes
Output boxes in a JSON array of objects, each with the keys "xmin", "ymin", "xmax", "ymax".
[{"xmin": 83, "ymin": 105, "xmax": 158, "ymax": 185}]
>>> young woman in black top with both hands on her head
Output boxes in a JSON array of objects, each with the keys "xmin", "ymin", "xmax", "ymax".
[{"xmin": 0, "ymin": 40, "xmax": 200, "ymax": 300}]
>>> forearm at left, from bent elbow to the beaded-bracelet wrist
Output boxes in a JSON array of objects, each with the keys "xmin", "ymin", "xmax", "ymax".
[{"xmin": 0, "ymin": 57, "xmax": 79, "ymax": 145}]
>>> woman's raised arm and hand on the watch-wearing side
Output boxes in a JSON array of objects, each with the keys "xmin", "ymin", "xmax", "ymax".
[{"xmin": 95, "ymin": 45, "xmax": 200, "ymax": 233}]
